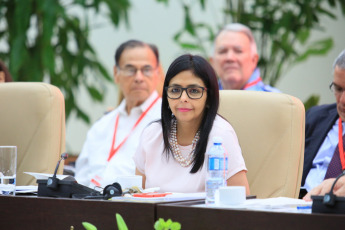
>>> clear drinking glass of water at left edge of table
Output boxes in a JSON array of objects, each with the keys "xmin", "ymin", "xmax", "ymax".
[{"xmin": 0, "ymin": 146, "xmax": 17, "ymax": 195}]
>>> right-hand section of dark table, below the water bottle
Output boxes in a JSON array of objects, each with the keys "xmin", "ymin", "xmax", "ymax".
[{"xmin": 156, "ymin": 201, "xmax": 345, "ymax": 230}]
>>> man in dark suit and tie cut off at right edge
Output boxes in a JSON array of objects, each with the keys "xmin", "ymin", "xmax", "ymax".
[{"xmin": 300, "ymin": 50, "xmax": 345, "ymax": 196}]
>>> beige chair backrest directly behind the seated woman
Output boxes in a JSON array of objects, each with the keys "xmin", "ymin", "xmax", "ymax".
[{"xmin": 219, "ymin": 90, "xmax": 305, "ymax": 198}]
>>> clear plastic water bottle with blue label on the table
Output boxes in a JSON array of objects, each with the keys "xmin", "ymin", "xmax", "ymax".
[{"xmin": 205, "ymin": 137, "xmax": 228, "ymax": 204}]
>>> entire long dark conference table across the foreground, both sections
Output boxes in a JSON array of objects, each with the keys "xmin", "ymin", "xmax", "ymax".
[{"xmin": 0, "ymin": 196, "xmax": 345, "ymax": 230}]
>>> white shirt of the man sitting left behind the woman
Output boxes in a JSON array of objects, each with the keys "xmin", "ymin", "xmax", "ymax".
[{"xmin": 75, "ymin": 91, "xmax": 162, "ymax": 188}]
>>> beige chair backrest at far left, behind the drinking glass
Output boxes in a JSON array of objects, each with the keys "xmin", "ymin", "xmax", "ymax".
[{"xmin": 0, "ymin": 82, "xmax": 65, "ymax": 185}]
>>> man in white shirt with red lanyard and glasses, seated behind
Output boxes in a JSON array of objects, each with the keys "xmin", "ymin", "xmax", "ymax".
[{"xmin": 75, "ymin": 40, "xmax": 161, "ymax": 188}]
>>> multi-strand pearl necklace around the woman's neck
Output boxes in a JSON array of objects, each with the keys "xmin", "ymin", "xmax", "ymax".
[{"xmin": 169, "ymin": 119, "xmax": 200, "ymax": 167}]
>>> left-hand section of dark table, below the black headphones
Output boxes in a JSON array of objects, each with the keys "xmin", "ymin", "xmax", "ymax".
[{"xmin": 0, "ymin": 196, "xmax": 156, "ymax": 230}]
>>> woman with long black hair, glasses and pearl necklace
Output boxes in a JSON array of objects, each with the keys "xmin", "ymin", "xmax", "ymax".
[{"xmin": 134, "ymin": 54, "xmax": 249, "ymax": 194}]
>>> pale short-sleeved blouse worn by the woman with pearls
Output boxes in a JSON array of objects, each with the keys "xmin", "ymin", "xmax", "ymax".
[{"xmin": 133, "ymin": 115, "xmax": 247, "ymax": 193}]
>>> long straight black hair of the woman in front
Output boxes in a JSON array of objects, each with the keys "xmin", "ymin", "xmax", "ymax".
[{"xmin": 161, "ymin": 54, "xmax": 219, "ymax": 173}]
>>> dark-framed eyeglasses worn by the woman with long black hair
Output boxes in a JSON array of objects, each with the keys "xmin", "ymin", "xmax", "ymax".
[{"xmin": 165, "ymin": 86, "xmax": 207, "ymax": 99}]
